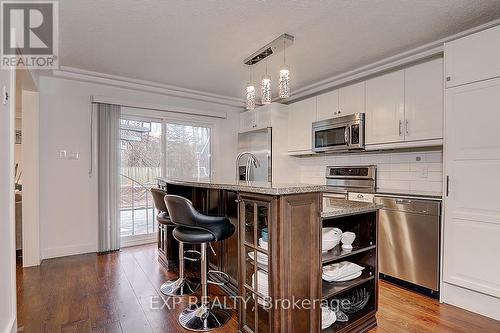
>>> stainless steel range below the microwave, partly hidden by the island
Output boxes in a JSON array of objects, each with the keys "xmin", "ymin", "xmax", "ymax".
[{"xmin": 323, "ymin": 165, "xmax": 377, "ymax": 207}]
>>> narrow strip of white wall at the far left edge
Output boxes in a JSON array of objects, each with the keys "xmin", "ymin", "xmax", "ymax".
[{"xmin": 0, "ymin": 69, "xmax": 16, "ymax": 333}]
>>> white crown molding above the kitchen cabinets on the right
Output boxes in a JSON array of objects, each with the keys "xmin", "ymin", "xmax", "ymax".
[{"xmin": 286, "ymin": 19, "xmax": 500, "ymax": 104}]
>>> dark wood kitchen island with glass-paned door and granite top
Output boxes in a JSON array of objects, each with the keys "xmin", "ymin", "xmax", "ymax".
[{"xmin": 158, "ymin": 179, "xmax": 376, "ymax": 332}]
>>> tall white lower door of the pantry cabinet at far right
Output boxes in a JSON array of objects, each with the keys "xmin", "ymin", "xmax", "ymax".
[{"xmin": 443, "ymin": 79, "xmax": 500, "ymax": 297}]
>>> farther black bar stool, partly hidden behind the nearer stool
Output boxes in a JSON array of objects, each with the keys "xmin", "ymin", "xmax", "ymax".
[{"xmin": 151, "ymin": 188, "xmax": 200, "ymax": 296}]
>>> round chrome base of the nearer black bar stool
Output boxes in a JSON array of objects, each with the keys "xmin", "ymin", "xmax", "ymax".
[{"xmin": 179, "ymin": 303, "xmax": 231, "ymax": 332}]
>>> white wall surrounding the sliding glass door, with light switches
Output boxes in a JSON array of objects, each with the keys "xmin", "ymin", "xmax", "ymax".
[{"xmin": 39, "ymin": 77, "xmax": 240, "ymax": 259}]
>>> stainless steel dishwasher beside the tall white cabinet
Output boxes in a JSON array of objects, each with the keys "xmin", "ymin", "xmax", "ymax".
[{"xmin": 374, "ymin": 196, "xmax": 441, "ymax": 293}]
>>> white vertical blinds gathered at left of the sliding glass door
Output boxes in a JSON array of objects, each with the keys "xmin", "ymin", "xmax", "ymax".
[{"xmin": 94, "ymin": 103, "xmax": 120, "ymax": 252}]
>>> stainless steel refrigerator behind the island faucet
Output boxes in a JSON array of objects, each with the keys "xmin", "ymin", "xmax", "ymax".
[{"xmin": 238, "ymin": 127, "xmax": 272, "ymax": 182}]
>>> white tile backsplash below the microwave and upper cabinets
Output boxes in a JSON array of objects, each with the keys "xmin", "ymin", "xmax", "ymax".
[{"xmin": 298, "ymin": 150, "xmax": 443, "ymax": 194}]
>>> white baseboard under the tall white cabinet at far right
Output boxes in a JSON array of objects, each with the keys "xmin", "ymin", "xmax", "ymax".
[{"xmin": 441, "ymin": 282, "xmax": 500, "ymax": 320}]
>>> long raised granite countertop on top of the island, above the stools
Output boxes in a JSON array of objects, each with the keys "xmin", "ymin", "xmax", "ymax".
[{"xmin": 158, "ymin": 178, "xmax": 327, "ymax": 195}]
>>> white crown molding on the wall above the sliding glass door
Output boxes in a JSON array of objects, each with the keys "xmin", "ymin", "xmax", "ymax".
[{"xmin": 52, "ymin": 66, "xmax": 245, "ymax": 108}]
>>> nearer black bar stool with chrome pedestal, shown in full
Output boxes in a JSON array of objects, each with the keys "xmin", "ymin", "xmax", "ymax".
[{"xmin": 165, "ymin": 195, "xmax": 235, "ymax": 331}]
